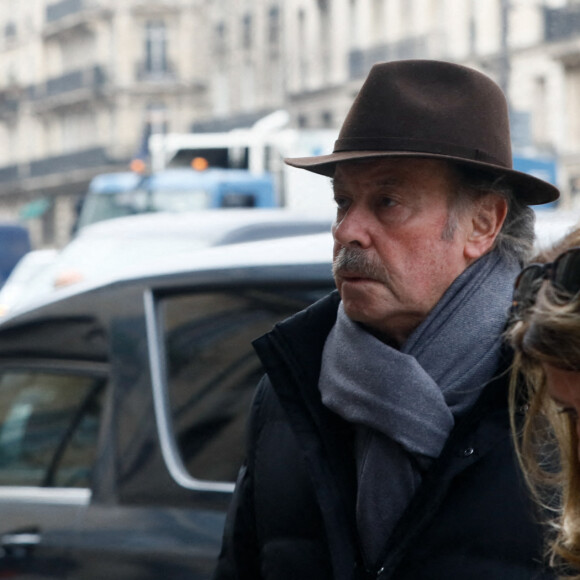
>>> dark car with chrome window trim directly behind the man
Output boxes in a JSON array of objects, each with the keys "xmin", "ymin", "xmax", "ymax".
[{"xmin": 0, "ymin": 234, "xmax": 334, "ymax": 580}]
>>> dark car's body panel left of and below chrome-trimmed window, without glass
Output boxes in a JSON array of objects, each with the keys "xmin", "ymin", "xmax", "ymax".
[{"xmin": 57, "ymin": 285, "xmax": 233, "ymax": 580}]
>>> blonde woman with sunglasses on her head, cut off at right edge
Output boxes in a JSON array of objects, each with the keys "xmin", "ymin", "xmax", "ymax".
[{"xmin": 508, "ymin": 228, "xmax": 580, "ymax": 579}]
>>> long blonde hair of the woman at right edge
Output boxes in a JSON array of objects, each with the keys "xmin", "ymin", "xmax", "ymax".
[{"xmin": 507, "ymin": 228, "xmax": 580, "ymax": 580}]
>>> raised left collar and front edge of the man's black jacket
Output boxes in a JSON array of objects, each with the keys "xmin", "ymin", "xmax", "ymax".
[{"xmin": 254, "ymin": 292, "xmax": 359, "ymax": 580}]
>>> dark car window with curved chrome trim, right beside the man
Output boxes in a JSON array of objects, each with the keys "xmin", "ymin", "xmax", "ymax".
[{"xmin": 162, "ymin": 288, "xmax": 329, "ymax": 482}]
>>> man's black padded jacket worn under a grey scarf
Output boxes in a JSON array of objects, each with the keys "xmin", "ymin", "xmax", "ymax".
[{"xmin": 214, "ymin": 293, "xmax": 554, "ymax": 580}]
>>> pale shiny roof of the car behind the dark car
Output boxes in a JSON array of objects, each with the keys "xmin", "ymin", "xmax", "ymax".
[{"xmin": 13, "ymin": 208, "xmax": 332, "ymax": 304}]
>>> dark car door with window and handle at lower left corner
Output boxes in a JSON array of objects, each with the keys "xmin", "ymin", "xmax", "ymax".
[{"xmin": 0, "ymin": 357, "xmax": 107, "ymax": 579}]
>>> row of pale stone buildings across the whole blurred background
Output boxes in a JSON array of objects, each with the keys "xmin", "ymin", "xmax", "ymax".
[{"xmin": 0, "ymin": 0, "xmax": 580, "ymax": 246}]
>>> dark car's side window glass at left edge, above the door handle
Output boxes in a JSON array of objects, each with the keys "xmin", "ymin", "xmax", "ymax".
[{"xmin": 0, "ymin": 370, "xmax": 104, "ymax": 487}]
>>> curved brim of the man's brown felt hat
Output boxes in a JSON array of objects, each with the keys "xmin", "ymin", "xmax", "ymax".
[{"xmin": 284, "ymin": 151, "xmax": 560, "ymax": 205}]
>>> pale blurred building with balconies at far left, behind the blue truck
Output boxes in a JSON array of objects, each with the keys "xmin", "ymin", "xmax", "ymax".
[{"xmin": 0, "ymin": 0, "xmax": 207, "ymax": 245}]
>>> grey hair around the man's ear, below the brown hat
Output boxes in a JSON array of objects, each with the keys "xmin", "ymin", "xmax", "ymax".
[{"xmin": 443, "ymin": 165, "xmax": 536, "ymax": 265}]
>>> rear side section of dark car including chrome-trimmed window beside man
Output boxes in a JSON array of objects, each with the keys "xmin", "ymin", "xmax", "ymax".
[{"xmin": 63, "ymin": 280, "xmax": 329, "ymax": 580}]
